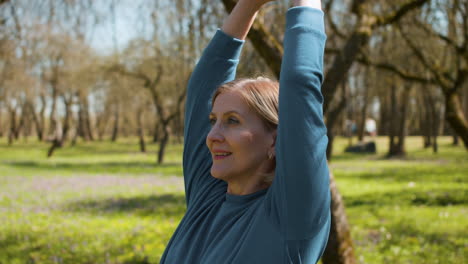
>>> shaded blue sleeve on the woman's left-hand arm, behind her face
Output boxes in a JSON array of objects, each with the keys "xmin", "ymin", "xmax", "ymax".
[{"xmin": 183, "ymin": 30, "xmax": 244, "ymax": 207}]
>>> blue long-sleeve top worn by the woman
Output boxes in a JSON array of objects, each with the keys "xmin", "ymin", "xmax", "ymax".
[{"xmin": 161, "ymin": 7, "xmax": 330, "ymax": 264}]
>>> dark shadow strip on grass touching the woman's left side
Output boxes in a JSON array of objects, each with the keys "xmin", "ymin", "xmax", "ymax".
[{"xmin": 63, "ymin": 194, "xmax": 186, "ymax": 217}]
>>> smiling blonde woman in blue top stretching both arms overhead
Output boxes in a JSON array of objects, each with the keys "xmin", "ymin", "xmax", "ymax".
[{"xmin": 161, "ymin": 0, "xmax": 330, "ymax": 264}]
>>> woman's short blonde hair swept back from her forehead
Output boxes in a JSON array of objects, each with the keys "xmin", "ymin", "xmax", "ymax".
[{"xmin": 211, "ymin": 77, "xmax": 279, "ymax": 184}]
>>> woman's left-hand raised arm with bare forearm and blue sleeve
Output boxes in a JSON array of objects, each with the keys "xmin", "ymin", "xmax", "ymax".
[{"xmin": 183, "ymin": 0, "xmax": 271, "ymax": 206}]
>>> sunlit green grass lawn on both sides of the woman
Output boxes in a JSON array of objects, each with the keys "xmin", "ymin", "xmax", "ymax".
[{"xmin": 0, "ymin": 137, "xmax": 468, "ymax": 264}]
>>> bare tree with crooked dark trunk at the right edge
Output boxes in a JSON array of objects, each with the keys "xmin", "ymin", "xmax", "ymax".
[{"xmin": 362, "ymin": 0, "xmax": 468, "ymax": 149}]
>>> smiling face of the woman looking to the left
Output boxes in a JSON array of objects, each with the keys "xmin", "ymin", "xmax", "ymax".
[{"xmin": 206, "ymin": 92, "xmax": 275, "ymax": 182}]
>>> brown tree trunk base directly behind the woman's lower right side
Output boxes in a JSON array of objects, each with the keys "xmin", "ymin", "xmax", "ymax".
[{"xmin": 322, "ymin": 173, "xmax": 356, "ymax": 264}]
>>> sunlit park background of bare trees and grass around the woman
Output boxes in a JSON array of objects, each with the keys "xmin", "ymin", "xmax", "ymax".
[{"xmin": 0, "ymin": 0, "xmax": 468, "ymax": 263}]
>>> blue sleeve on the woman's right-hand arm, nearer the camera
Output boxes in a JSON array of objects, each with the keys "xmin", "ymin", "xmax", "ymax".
[{"xmin": 265, "ymin": 7, "xmax": 330, "ymax": 240}]
